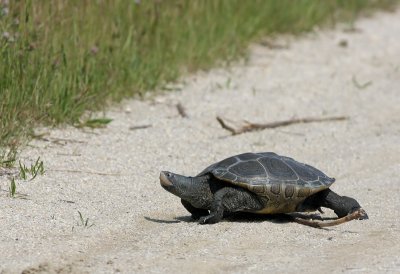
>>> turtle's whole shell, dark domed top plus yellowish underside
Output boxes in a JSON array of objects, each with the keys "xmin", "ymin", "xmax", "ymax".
[{"xmin": 198, "ymin": 152, "xmax": 335, "ymax": 213}]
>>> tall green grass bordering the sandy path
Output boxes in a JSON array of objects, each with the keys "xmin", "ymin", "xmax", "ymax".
[{"xmin": 0, "ymin": 0, "xmax": 397, "ymax": 156}]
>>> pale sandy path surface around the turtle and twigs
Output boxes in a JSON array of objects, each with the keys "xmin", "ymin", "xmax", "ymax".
[{"xmin": 0, "ymin": 11, "xmax": 400, "ymax": 273}]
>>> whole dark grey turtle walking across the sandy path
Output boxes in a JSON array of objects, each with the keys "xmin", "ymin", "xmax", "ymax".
[{"xmin": 160, "ymin": 152, "xmax": 368, "ymax": 227}]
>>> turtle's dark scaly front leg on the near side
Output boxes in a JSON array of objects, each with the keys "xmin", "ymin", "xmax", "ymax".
[{"xmin": 199, "ymin": 186, "xmax": 263, "ymax": 224}]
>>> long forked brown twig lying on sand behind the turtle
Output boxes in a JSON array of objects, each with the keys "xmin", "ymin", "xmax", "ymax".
[{"xmin": 217, "ymin": 116, "xmax": 349, "ymax": 135}]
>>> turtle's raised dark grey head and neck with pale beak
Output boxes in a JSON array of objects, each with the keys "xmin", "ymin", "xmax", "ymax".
[{"xmin": 160, "ymin": 171, "xmax": 212, "ymax": 207}]
